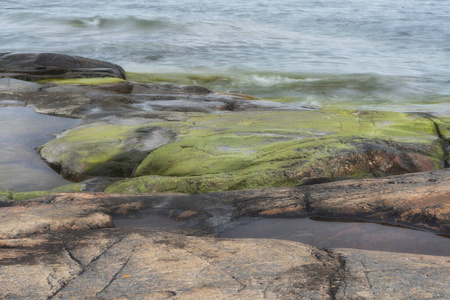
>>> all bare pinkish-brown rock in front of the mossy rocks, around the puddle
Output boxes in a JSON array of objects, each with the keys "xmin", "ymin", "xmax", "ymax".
[{"xmin": 0, "ymin": 170, "xmax": 450, "ymax": 299}]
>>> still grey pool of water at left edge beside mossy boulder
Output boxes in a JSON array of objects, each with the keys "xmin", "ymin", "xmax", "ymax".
[{"xmin": 0, "ymin": 107, "xmax": 81, "ymax": 192}]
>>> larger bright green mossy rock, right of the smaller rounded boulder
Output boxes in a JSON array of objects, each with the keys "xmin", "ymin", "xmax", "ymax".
[{"xmin": 106, "ymin": 111, "xmax": 445, "ymax": 193}]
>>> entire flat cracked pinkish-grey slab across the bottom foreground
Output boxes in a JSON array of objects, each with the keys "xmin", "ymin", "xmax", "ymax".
[{"xmin": 0, "ymin": 229, "xmax": 450, "ymax": 299}]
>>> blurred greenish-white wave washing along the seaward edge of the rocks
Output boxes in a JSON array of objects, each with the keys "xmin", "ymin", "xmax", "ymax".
[{"xmin": 128, "ymin": 69, "xmax": 450, "ymax": 111}]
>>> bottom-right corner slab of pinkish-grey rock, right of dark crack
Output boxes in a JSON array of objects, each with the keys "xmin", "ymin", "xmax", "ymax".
[{"xmin": 335, "ymin": 249, "xmax": 450, "ymax": 299}]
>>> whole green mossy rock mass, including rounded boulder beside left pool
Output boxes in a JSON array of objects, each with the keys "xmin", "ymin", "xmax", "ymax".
[{"xmin": 33, "ymin": 111, "xmax": 446, "ymax": 194}]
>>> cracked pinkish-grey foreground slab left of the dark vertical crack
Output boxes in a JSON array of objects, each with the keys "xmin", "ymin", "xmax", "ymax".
[{"xmin": 0, "ymin": 230, "xmax": 343, "ymax": 299}]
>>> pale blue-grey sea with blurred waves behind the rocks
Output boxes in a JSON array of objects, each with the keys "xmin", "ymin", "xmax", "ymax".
[{"xmin": 0, "ymin": 0, "xmax": 450, "ymax": 115}]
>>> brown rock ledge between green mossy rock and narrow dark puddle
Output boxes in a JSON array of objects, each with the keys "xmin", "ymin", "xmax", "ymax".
[{"xmin": 0, "ymin": 169, "xmax": 450, "ymax": 238}]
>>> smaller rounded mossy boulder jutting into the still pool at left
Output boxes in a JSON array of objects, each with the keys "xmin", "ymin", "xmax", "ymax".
[{"xmin": 39, "ymin": 122, "xmax": 178, "ymax": 179}]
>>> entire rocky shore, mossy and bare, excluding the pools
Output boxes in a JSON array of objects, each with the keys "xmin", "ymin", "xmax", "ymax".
[{"xmin": 0, "ymin": 53, "xmax": 450, "ymax": 299}]
